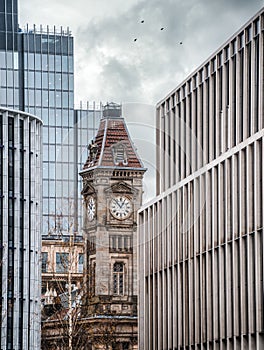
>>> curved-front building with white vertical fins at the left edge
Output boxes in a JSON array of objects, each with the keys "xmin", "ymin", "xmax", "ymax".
[{"xmin": 0, "ymin": 107, "xmax": 42, "ymax": 350}]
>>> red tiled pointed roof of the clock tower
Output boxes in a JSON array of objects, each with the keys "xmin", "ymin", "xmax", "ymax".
[{"xmin": 83, "ymin": 103, "xmax": 145, "ymax": 170}]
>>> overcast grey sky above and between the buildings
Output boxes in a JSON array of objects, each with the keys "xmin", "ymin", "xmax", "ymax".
[{"xmin": 18, "ymin": 0, "xmax": 264, "ymax": 198}]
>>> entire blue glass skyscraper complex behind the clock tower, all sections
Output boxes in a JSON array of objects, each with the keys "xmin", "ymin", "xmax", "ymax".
[{"xmin": 0, "ymin": 0, "xmax": 101, "ymax": 238}]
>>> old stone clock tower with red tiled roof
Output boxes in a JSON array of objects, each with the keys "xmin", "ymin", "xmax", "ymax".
[{"xmin": 80, "ymin": 103, "xmax": 146, "ymax": 350}]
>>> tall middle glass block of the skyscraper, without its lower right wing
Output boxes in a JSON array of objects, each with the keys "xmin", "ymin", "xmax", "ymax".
[{"xmin": 19, "ymin": 27, "xmax": 74, "ymax": 234}]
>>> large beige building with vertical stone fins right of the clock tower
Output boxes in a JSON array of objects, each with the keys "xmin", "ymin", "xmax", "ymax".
[{"xmin": 138, "ymin": 9, "xmax": 264, "ymax": 350}]
